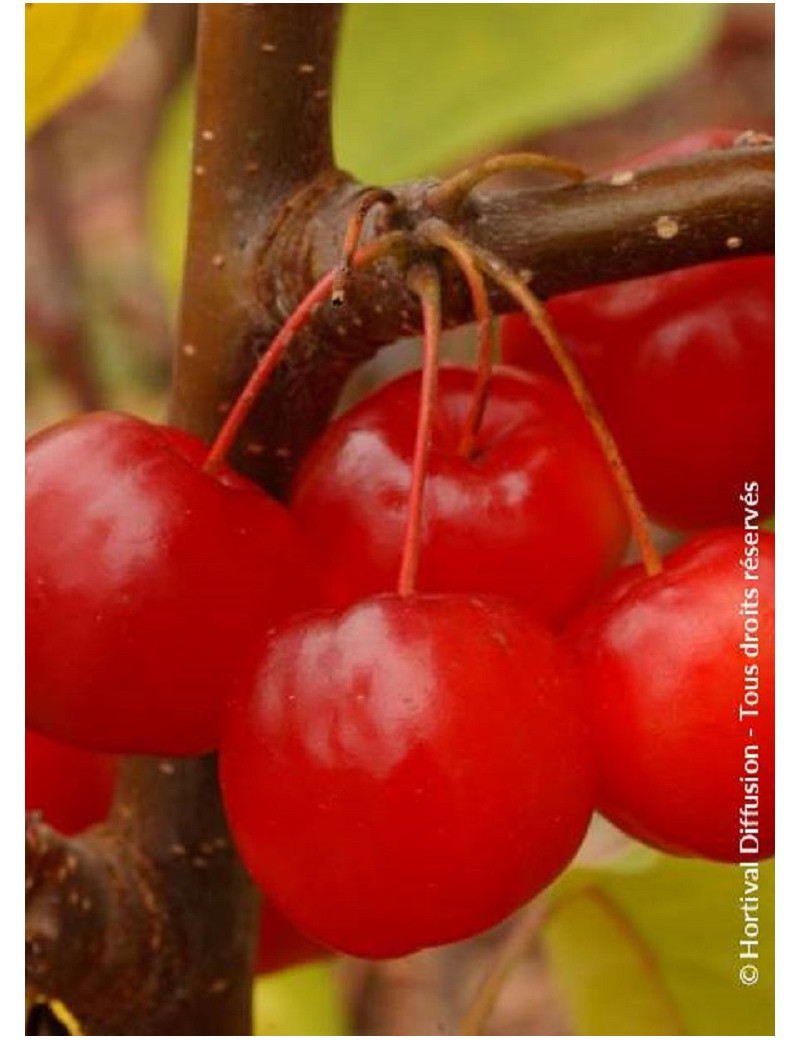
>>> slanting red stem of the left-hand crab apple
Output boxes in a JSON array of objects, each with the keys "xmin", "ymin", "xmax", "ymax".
[{"xmin": 203, "ymin": 231, "xmax": 406, "ymax": 473}]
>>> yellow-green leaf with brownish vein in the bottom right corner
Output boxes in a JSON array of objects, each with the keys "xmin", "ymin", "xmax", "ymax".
[{"xmin": 544, "ymin": 855, "xmax": 775, "ymax": 1036}]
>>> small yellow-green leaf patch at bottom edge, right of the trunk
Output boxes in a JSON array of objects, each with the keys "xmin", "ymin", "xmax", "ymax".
[{"xmin": 253, "ymin": 963, "xmax": 349, "ymax": 1037}]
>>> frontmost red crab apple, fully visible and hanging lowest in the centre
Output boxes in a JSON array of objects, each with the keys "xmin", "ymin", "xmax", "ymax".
[{"xmin": 221, "ymin": 595, "xmax": 593, "ymax": 957}]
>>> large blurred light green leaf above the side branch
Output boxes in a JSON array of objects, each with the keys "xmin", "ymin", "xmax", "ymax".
[{"xmin": 334, "ymin": 3, "xmax": 721, "ymax": 183}]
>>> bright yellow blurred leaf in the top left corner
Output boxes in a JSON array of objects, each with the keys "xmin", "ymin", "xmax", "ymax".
[{"xmin": 25, "ymin": 3, "xmax": 145, "ymax": 133}]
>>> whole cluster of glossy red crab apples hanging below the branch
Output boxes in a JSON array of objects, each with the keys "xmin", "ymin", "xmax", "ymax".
[{"xmin": 26, "ymin": 135, "xmax": 774, "ymax": 957}]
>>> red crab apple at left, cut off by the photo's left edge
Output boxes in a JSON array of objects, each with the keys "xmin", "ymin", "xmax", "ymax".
[{"xmin": 25, "ymin": 413, "xmax": 311, "ymax": 755}]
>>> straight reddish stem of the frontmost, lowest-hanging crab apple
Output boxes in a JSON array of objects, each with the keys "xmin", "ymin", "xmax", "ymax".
[{"xmin": 397, "ymin": 263, "xmax": 442, "ymax": 596}]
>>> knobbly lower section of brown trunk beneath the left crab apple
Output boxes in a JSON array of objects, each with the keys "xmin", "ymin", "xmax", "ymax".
[{"xmin": 25, "ymin": 757, "xmax": 256, "ymax": 1036}]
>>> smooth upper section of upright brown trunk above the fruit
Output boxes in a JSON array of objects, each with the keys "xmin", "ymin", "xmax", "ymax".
[{"xmin": 172, "ymin": 4, "xmax": 341, "ymax": 439}]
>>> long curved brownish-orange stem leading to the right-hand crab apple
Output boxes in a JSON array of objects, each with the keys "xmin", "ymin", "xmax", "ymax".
[{"xmin": 422, "ymin": 220, "xmax": 663, "ymax": 575}]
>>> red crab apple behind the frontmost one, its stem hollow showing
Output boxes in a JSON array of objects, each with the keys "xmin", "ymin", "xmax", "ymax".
[{"xmin": 291, "ymin": 367, "xmax": 628, "ymax": 621}]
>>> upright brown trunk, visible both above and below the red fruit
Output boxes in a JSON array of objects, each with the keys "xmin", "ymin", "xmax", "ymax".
[{"xmin": 26, "ymin": 4, "xmax": 338, "ymax": 1036}]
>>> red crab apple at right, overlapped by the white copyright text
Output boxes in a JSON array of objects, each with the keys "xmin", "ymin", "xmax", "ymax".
[{"xmin": 568, "ymin": 528, "xmax": 775, "ymax": 862}]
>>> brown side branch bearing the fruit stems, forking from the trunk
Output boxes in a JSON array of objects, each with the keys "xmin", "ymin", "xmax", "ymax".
[{"xmin": 207, "ymin": 146, "xmax": 775, "ymax": 494}]
